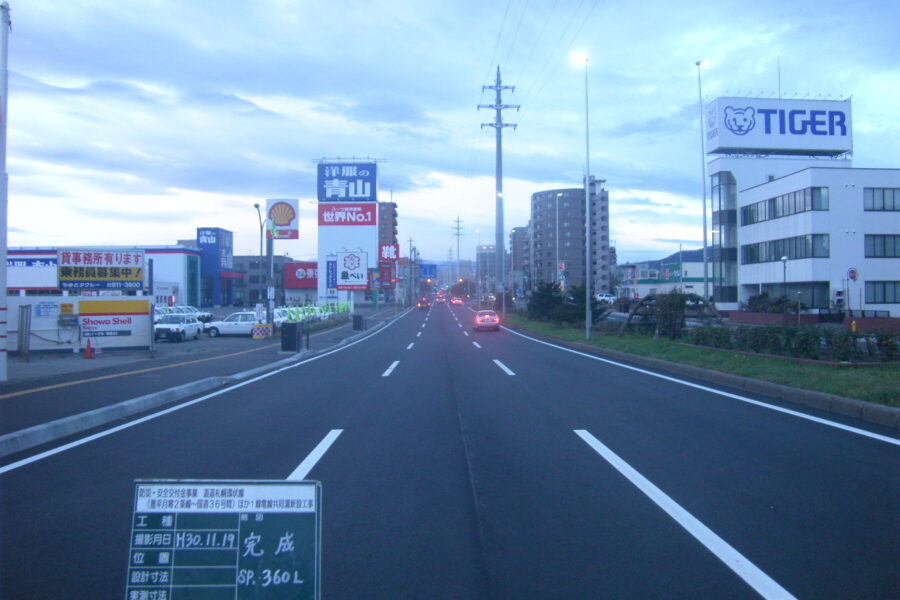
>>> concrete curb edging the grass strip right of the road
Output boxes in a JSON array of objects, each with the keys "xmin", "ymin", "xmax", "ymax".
[{"xmin": 506, "ymin": 325, "xmax": 900, "ymax": 429}]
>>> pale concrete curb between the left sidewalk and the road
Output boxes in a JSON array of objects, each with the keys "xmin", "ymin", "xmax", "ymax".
[{"xmin": 0, "ymin": 313, "xmax": 404, "ymax": 457}]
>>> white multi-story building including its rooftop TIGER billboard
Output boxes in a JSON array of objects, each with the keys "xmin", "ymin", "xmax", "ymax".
[{"xmin": 705, "ymin": 98, "xmax": 900, "ymax": 316}]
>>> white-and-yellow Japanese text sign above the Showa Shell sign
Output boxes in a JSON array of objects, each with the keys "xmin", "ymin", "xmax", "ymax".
[{"xmin": 56, "ymin": 248, "xmax": 144, "ymax": 290}]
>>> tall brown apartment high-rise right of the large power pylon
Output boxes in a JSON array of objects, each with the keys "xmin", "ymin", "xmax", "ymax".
[{"xmin": 530, "ymin": 176, "xmax": 611, "ymax": 293}]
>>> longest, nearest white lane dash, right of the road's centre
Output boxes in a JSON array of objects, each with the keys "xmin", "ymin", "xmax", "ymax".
[{"xmin": 574, "ymin": 429, "xmax": 794, "ymax": 598}]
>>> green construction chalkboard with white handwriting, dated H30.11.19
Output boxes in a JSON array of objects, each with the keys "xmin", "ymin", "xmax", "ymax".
[{"xmin": 125, "ymin": 480, "xmax": 322, "ymax": 600}]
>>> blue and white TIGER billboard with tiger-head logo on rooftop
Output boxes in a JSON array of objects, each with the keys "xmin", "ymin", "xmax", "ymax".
[{"xmin": 704, "ymin": 98, "xmax": 853, "ymax": 156}]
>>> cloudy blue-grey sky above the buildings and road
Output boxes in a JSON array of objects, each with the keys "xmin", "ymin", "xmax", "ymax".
[{"xmin": 7, "ymin": 0, "xmax": 900, "ymax": 261}]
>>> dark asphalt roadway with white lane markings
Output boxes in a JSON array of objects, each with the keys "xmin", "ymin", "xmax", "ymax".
[{"xmin": 0, "ymin": 304, "xmax": 900, "ymax": 599}]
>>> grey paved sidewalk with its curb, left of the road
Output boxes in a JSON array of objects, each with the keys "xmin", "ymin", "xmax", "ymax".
[{"xmin": 0, "ymin": 307, "xmax": 403, "ymax": 456}]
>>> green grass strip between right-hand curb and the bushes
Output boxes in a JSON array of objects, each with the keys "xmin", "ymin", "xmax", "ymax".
[{"xmin": 506, "ymin": 314, "xmax": 900, "ymax": 406}]
